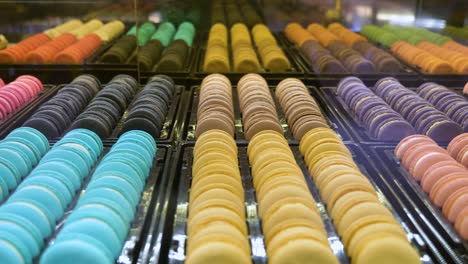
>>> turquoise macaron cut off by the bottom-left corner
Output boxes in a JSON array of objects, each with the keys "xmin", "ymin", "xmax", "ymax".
[{"xmin": 0, "ymin": 231, "xmax": 33, "ymax": 264}]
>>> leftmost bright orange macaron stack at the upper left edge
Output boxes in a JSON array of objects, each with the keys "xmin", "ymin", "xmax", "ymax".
[{"xmin": 0, "ymin": 33, "xmax": 52, "ymax": 63}]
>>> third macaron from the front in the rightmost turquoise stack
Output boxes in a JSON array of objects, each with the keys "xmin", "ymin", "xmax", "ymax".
[{"xmin": 65, "ymin": 205, "xmax": 129, "ymax": 241}]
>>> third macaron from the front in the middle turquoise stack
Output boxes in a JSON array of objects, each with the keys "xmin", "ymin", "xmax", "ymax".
[{"xmin": 0, "ymin": 200, "xmax": 55, "ymax": 238}]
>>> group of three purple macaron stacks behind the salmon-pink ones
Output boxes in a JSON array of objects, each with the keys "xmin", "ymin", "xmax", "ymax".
[{"xmin": 337, "ymin": 77, "xmax": 468, "ymax": 142}]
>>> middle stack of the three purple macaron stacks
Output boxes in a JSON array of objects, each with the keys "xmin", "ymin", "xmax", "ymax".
[{"xmin": 373, "ymin": 77, "xmax": 463, "ymax": 142}]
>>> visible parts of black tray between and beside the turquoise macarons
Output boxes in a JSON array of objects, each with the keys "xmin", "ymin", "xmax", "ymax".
[{"xmin": 26, "ymin": 145, "xmax": 171, "ymax": 264}]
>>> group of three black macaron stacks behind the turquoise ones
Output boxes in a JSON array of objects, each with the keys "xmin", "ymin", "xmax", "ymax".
[{"xmin": 23, "ymin": 74, "xmax": 175, "ymax": 138}]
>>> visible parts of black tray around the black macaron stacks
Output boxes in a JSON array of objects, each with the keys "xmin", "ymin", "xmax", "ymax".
[{"xmin": 5, "ymin": 85, "xmax": 184, "ymax": 144}]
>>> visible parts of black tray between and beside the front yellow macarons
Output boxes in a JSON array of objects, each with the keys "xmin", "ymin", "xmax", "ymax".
[{"xmin": 154, "ymin": 143, "xmax": 438, "ymax": 264}]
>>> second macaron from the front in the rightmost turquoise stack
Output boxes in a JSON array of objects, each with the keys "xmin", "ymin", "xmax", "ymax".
[{"xmin": 60, "ymin": 218, "xmax": 123, "ymax": 258}]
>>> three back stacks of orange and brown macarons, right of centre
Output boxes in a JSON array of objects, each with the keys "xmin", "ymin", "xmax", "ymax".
[{"xmin": 284, "ymin": 23, "xmax": 403, "ymax": 73}]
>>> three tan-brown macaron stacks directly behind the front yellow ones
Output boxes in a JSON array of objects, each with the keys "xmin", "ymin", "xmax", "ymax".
[{"xmin": 195, "ymin": 73, "xmax": 329, "ymax": 140}]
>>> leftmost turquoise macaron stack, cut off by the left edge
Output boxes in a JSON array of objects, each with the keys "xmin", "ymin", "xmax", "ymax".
[{"xmin": 0, "ymin": 128, "xmax": 49, "ymax": 200}]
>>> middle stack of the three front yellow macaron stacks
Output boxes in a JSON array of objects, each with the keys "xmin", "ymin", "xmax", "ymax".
[{"xmin": 247, "ymin": 131, "xmax": 338, "ymax": 263}]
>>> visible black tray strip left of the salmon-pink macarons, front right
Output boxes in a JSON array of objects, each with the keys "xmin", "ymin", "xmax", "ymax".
[{"xmin": 365, "ymin": 144, "xmax": 468, "ymax": 263}]
